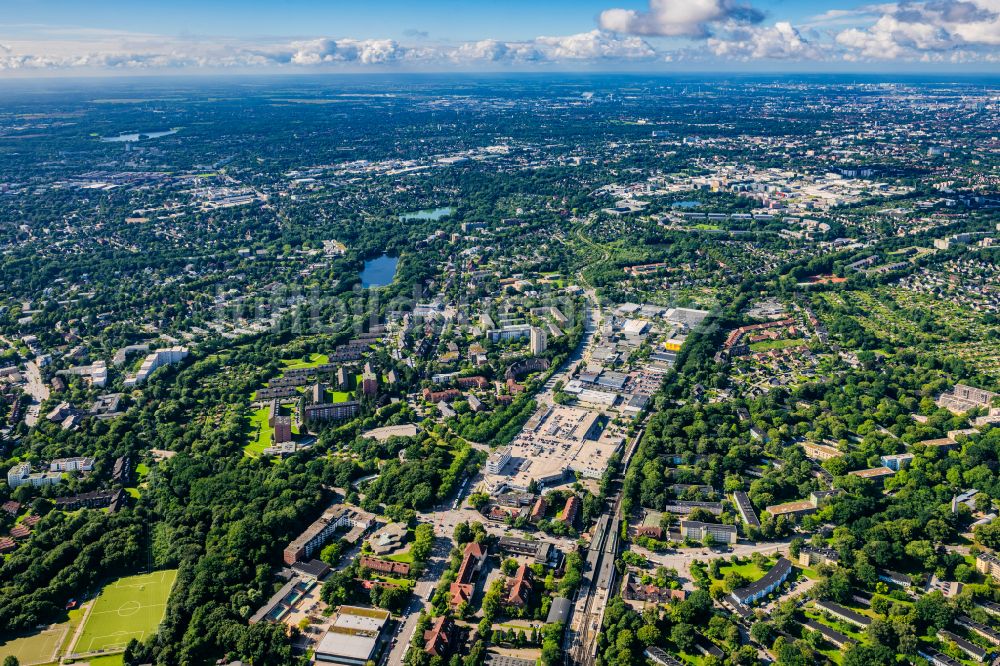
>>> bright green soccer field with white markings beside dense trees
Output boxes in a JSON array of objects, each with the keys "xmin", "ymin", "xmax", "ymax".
[{"xmin": 73, "ymin": 569, "xmax": 177, "ymax": 654}]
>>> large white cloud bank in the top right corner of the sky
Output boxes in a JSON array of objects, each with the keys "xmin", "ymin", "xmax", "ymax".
[{"xmin": 836, "ymin": 0, "xmax": 1000, "ymax": 60}]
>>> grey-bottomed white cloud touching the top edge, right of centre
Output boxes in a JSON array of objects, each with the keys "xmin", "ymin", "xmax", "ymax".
[{"xmin": 600, "ymin": 0, "xmax": 763, "ymax": 37}]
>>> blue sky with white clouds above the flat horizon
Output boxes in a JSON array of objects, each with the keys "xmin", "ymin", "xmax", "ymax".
[{"xmin": 0, "ymin": 0, "xmax": 1000, "ymax": 78}]
